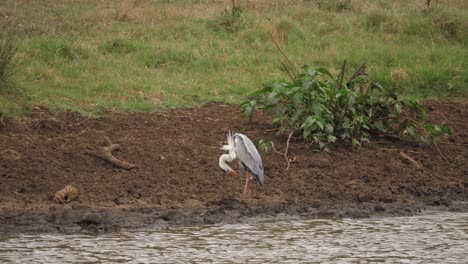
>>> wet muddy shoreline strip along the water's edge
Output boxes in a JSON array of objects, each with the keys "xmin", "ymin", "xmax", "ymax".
[{"xmin": 0, "ymin": 202, "xmax": 468, "ymax": 237}]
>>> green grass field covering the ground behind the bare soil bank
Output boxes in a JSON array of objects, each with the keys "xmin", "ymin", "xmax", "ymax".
[{"xmin": 0, "ymin": 0, "xmax": 468, "ymax": 116}]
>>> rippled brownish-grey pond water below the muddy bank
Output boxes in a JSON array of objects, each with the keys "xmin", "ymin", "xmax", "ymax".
[{"xmin": 0, "ymin": 212, "xmax": 468, "ymax": 263}]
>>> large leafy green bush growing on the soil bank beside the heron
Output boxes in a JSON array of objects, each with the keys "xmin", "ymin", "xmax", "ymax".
[{"xmin": 242, "ymin": 64, "xmax": 450, "ymax": 149}]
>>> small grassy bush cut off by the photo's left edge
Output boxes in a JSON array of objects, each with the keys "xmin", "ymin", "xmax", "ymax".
[{"xmin": 0, "ymin": 35, "xmax": 19, "ymax": 89}]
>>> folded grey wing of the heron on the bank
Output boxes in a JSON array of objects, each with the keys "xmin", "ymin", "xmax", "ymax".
[{"xmin": 234, "ymin": 133, "xmax": 264, "ymax": 185}]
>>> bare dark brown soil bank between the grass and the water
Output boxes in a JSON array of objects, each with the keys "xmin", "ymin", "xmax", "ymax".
[{"xmin": 0, "ymin": 102, "xmax": 468, "ymax": 233}]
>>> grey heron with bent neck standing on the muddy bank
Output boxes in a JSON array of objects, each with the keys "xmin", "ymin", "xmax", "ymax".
[{"xmin": 219, "ymin": 132, "xmax": 265, "ymax": 193}]
